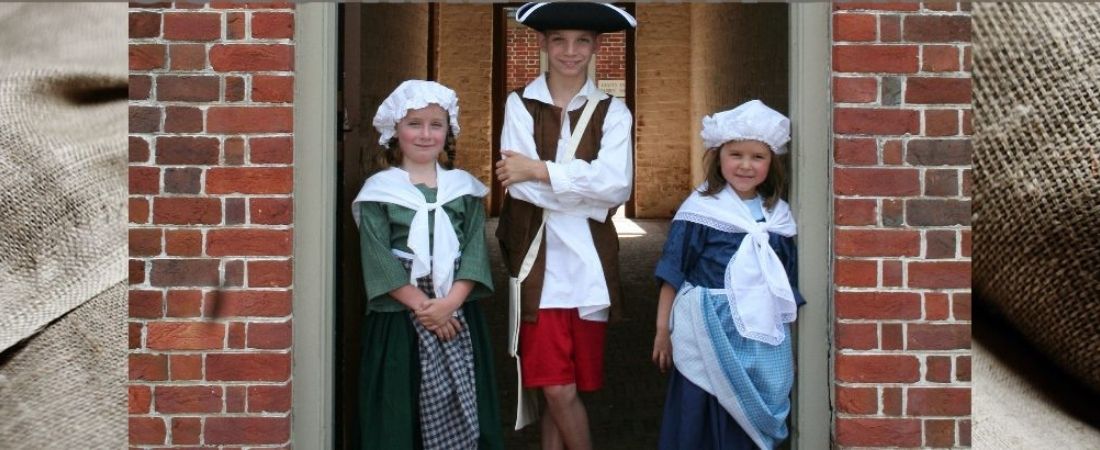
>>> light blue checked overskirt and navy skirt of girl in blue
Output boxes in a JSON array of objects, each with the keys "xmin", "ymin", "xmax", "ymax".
[{"xmin": 660, "ymin": 286, "xmax": 794, "ymax": 449}]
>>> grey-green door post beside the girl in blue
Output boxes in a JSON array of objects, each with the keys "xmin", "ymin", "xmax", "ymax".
[{"xmin": 790, "ymin": 3, "xmax": 833, "ymax": 444}]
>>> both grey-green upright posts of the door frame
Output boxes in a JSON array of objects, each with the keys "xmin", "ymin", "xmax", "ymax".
[{"xmin": 290, "ymin": 2, "xmax": 833, "ymax": 449}]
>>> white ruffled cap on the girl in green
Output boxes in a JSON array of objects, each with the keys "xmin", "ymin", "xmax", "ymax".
[{"xmin": 373, "ymin": 79, "xmax": 459, "ymax": 146}]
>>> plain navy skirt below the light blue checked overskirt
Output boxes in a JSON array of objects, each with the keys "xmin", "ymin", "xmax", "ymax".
[{"xmin": 658, "ymin": 367, "xmax": 756, "ymax": 450}]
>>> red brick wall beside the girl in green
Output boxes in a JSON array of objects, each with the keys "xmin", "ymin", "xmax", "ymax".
[{"xmin": 129, "ymin": 2, "xmax": 294, "ymax": 448}]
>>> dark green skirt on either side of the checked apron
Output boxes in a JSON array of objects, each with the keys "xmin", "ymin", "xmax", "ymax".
[{"xmin": 359, "ymin": 300, "xmax": 504, "ymax": 450}]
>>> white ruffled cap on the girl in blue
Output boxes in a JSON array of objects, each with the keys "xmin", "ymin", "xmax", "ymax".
[{"xmin": 700, "ymin": 100, "xmax": 791, "ymax": 155}]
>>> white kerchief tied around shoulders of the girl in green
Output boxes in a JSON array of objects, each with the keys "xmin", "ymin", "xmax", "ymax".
[{"xmin": 352, "ymin": 165, "xmax": 488, "ymax": 298}]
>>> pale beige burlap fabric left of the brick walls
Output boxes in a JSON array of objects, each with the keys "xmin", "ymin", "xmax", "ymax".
[{"xmin": 0, "ymin": 3, "xmax": 128, "ymax": 449}]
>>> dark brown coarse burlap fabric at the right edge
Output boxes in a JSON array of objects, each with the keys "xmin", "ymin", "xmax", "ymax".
[{"xmin": 974, "ymin": 2, "xmax": 1100, "ymax": 391}]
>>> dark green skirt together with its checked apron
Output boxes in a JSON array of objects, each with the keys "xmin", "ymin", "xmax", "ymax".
[{"xmin": 360, "ymin": 257, "xmax": 503, "ymax": 449}]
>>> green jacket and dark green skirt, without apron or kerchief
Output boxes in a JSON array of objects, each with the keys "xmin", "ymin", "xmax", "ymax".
[{"xmin": 359, "ymin": 185, "xmax": 504, "ymax": 450}]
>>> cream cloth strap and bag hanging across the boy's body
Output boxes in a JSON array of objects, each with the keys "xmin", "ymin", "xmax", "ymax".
[{"xmin": 508, "ymin": 91, "xmax": 603, "ymax": 430}]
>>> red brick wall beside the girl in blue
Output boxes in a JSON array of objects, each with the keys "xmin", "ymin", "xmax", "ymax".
[{"xmin": 833, "ymin": 2, "xmax": 971, "ymax": 448}]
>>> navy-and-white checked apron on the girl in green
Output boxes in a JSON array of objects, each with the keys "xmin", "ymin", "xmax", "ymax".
[{"xmin": 393, "ymin": 250, "xmax": 480, "ymax": 450}]
